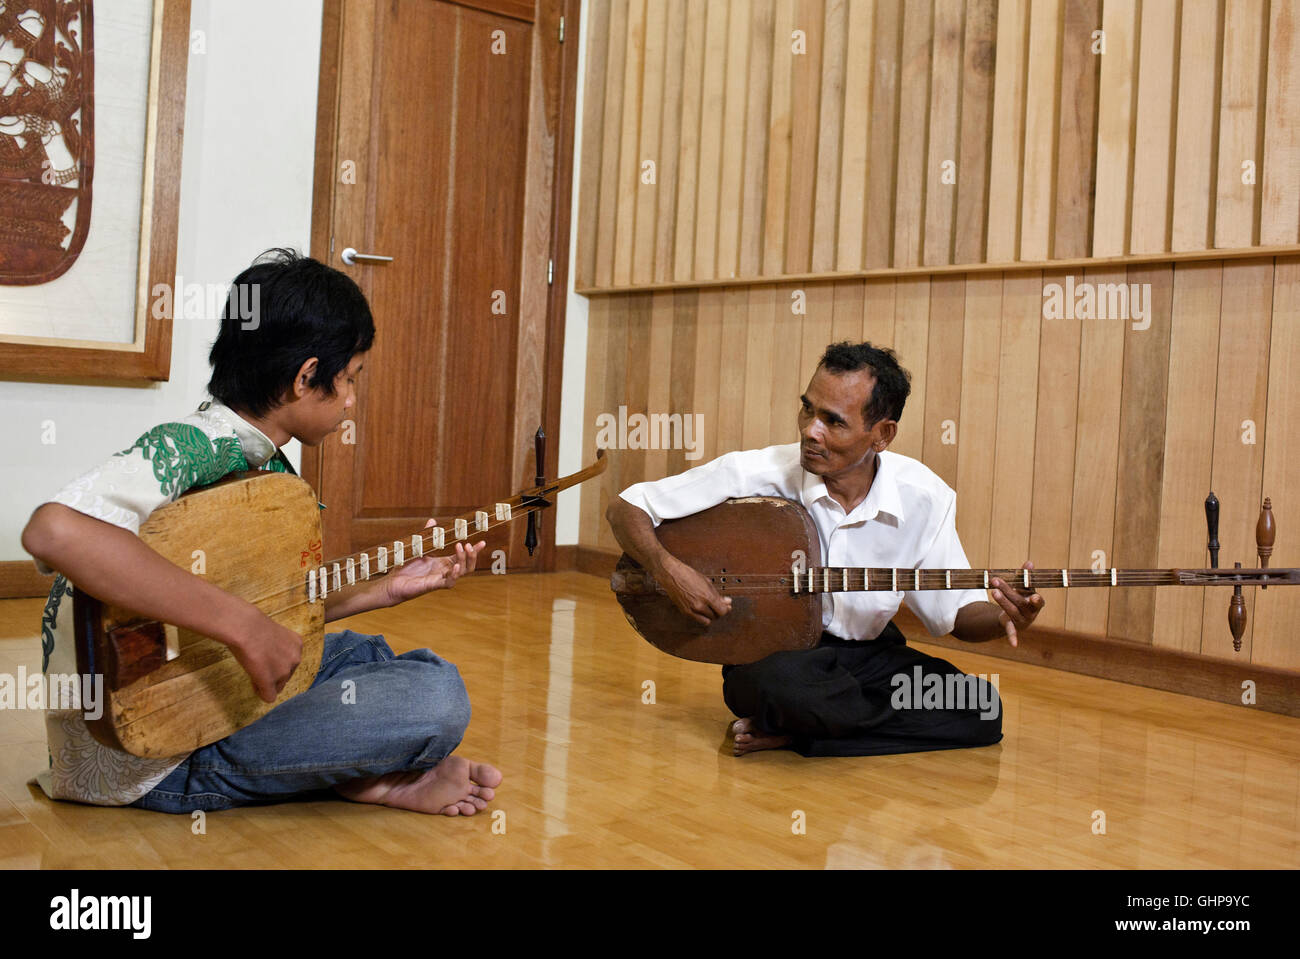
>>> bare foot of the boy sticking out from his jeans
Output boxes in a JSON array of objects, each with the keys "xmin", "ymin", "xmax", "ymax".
[{"xmin": 334, "ymin": 756, "xmax": 503, "ymax": 816}]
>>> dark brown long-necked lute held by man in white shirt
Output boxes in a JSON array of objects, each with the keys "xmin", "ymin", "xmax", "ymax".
[{"xmin": 610, "ymin": 492, "xmax": 1300, "ymax": 664}]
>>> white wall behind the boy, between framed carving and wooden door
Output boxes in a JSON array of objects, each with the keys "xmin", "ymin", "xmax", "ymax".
[{"xmin": 0, "ymin": 0, "xmax": 321, "ymax": 560}]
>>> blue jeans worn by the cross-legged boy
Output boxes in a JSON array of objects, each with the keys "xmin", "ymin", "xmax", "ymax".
[{"xmin": 131, "ymin": 630, "xmax": 469, "ymax": 812}]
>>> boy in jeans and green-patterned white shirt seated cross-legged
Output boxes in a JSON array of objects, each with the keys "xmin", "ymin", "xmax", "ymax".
[{"xmin": 22, "ymin": 251, "xmax": 502, "ymax": 816}]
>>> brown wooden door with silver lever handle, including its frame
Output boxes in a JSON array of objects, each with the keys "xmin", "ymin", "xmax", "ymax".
[{"xmin": 303, "ymin": 0, "xmax": 577, "ymax": 568}]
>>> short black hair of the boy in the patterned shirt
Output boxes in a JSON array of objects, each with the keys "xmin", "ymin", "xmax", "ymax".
[{"xmin": 208, "ymin": 248, "xmax": 374, "ymax": 416}]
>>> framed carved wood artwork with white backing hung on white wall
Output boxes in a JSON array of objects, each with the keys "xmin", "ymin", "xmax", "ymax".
[{"xmin": 0, "ymin": 0, "xmax": 190, "ymax": 381}]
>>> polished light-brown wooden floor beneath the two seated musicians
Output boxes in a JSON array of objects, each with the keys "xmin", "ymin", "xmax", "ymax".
[{"xmin": 0, "ymin": 573, "xmax": 1300, "ymax": 868}]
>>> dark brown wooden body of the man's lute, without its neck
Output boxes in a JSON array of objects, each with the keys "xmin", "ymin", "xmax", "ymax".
[{"xmin": 611, "ymin": 496, "xmax": 822, "ymax": 664}]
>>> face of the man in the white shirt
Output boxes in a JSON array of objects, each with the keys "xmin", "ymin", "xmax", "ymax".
[{"xmin": 798, "ymin": 366, "xmax": 893, "ymax": 478}]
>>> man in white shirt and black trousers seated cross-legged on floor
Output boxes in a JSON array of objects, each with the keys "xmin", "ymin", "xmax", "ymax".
[{"xmin": 607, "ymin": 343, "xmax": 1044, "ymax": 756}]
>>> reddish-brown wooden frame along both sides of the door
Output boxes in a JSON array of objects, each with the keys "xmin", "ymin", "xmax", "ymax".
[{"xmin": 302, "ymin": 0, "xmax": 581, "ymax": 572}]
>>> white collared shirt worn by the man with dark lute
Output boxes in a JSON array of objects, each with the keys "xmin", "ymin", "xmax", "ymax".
[{"xmin": 619, "ymin": 443, "xmax": 988, "ymax": 639}]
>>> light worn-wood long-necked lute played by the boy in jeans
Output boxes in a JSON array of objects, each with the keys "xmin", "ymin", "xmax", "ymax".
[{"xmin": 73, "ymin": 441, "xmax": 608, "ymax": 758}]
